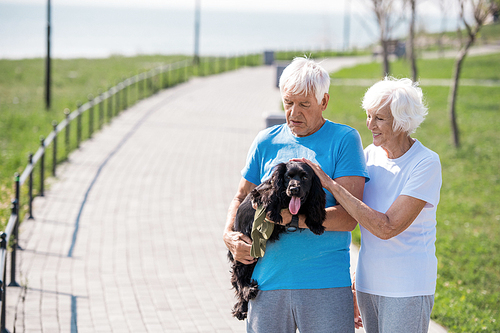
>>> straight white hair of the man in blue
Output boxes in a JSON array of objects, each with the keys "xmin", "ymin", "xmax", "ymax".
[{"xmin": 279, "ymin": 57, "xmax": 330, "ymax": 104}]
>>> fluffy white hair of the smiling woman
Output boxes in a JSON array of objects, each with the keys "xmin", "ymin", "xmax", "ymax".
[{"xmin": 362, "ymin": 76, "xmax": 427, "ymax": 134}]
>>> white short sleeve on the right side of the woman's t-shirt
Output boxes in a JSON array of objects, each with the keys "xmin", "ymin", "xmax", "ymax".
[{"xmin": 401, "ymin": 156, "xmax": 442, "ymax": 206}]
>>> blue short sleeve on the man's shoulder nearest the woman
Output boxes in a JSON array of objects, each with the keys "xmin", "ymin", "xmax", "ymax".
[{"xmin": 332, "ymin": 129, "xmax": 370, "ymax": 181}]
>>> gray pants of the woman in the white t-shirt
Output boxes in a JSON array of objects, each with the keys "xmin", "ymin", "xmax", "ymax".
[{"xmin": 356, "ymin": 291, "xmax": 434, "ymax": 333}]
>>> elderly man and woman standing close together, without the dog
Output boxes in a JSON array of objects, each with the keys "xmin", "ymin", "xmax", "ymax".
[{"xmin": 224, "ymin": 58, "xmax": 441, "ymax": 333}]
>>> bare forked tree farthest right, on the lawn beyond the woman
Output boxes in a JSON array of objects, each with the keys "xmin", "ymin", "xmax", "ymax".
[{"xmin": 448, "ymin": 0, "xmax": 496, "ymax": 147}]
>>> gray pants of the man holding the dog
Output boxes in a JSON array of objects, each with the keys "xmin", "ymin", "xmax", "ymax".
[{"xmin": 247, "ymin": 287, "xmax": 354, "ymax": 333}]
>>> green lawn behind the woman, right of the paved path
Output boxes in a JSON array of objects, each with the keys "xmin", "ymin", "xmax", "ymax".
[{"xmin": 326, "ymin": 54, "xmax": 500, "ymax": 332}]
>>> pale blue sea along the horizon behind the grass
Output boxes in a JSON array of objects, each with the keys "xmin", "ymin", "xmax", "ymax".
[{"xmin": 0, "ymin": 3, "xmax": 456, "ymax": 58}]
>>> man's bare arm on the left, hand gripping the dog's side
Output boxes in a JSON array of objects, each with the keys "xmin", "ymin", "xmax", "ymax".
[{"xmin": 223, "ymin": 178, "xmax": 256, "ymax": 265}]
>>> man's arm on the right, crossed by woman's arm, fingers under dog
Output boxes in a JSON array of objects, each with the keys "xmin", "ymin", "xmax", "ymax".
[{"xmin": 281, "ymin": 176, "xmax": 365, "ymax": 231}]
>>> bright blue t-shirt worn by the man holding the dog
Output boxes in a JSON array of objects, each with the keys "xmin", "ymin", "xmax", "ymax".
[{"xmin": 241, "ymin": 120, "xmax": 368, "ymax": 290}]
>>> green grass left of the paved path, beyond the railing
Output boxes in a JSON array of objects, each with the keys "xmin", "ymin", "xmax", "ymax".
[{"xmin": 0, "ymin": 55, "xmax": 262, "ymax": 226}]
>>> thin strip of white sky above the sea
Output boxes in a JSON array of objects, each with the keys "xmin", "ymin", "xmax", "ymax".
[{"xmin": 0, "ymin": 0, "xmax": 446, "ymax": 14}]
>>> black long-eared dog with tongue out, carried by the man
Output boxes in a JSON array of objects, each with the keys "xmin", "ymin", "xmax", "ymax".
[{"xmin": 228, "ymin": 162, "xmax": 326, "ymax": 320}]
